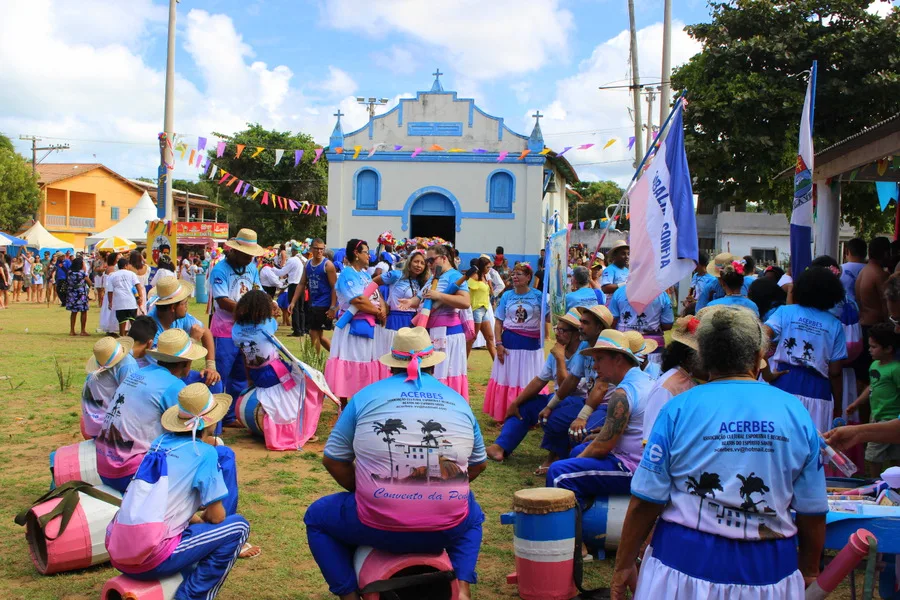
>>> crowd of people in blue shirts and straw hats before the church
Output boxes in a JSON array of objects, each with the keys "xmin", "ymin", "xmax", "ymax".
[{"xmin": 19, "ymin": 229, "xmax": 900, "ymax": 599}]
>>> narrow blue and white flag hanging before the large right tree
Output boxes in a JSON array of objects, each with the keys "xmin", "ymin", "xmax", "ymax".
[{"xmin": 791, "ymin": 61, "xmax": 816, "ymax": 278}]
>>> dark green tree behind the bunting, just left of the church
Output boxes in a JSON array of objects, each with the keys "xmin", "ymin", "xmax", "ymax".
[{"xmin": 203, "ymin": 123, "xmax": 328, "ymax": 245}]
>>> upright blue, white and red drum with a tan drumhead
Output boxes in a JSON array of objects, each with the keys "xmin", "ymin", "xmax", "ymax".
[{"xmin": 500, "ymin": 488, "xmax": 578, "ymax": 600}]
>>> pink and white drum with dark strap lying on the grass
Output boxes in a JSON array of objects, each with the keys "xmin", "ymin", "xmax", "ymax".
[{"xmin": 25, "ymin": 485, "xmax": 122, "ymax": 575}]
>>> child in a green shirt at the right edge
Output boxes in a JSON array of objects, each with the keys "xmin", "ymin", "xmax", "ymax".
[{"xmin": 847, "ymin": 323, "xmax": 900, "ymax": 477}]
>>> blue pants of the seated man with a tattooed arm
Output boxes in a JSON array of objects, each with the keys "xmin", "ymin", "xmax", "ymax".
[{"xmin": 547, "ymin": 455, "xmax": 632, "ymax": 506}]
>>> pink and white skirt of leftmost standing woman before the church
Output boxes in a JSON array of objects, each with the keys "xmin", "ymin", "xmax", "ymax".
[{"xmin": 325, "ymin": 326, "xmax": 390, "ymax": 398}]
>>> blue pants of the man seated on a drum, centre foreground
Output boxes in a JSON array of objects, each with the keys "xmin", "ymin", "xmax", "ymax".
[{"xmin": 303, "ymin": 492, "xmax": 484, "ymax": 596}]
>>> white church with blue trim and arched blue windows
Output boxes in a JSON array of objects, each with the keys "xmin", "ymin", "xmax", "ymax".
[{"xmin": 326, "ymin": 70, "xmax": 578, "ymax": 265}]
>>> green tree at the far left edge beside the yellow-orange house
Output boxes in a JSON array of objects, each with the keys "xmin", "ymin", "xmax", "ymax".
[{"xmin": 0, "ymin": 135, "xmax": 41, "ymax": 233}]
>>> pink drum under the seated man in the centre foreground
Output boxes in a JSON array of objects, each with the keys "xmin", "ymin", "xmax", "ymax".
[{"xmin": 353, "ymin": 546, "xmax": 459, "ymax": 600}]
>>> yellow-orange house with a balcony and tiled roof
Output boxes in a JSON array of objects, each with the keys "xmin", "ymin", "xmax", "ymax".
[{"xmin": 37, "ymin": 163, "xmax": 144, "ymax": 250}]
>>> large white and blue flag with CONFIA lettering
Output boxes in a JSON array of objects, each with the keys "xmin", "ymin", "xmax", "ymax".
[{"xmin": 625, "ymin": 99, "xmax": 699, "ymax": 311}]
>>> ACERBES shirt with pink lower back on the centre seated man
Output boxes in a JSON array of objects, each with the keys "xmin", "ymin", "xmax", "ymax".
[{"xmin": 325, "ymin": 373, "xmax": 487, "ymax": 531}]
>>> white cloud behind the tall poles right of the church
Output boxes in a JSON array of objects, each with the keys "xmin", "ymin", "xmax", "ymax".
[{"xmin": 525, "ymin": 21, "xmax": 700, "ymax": 185}]
